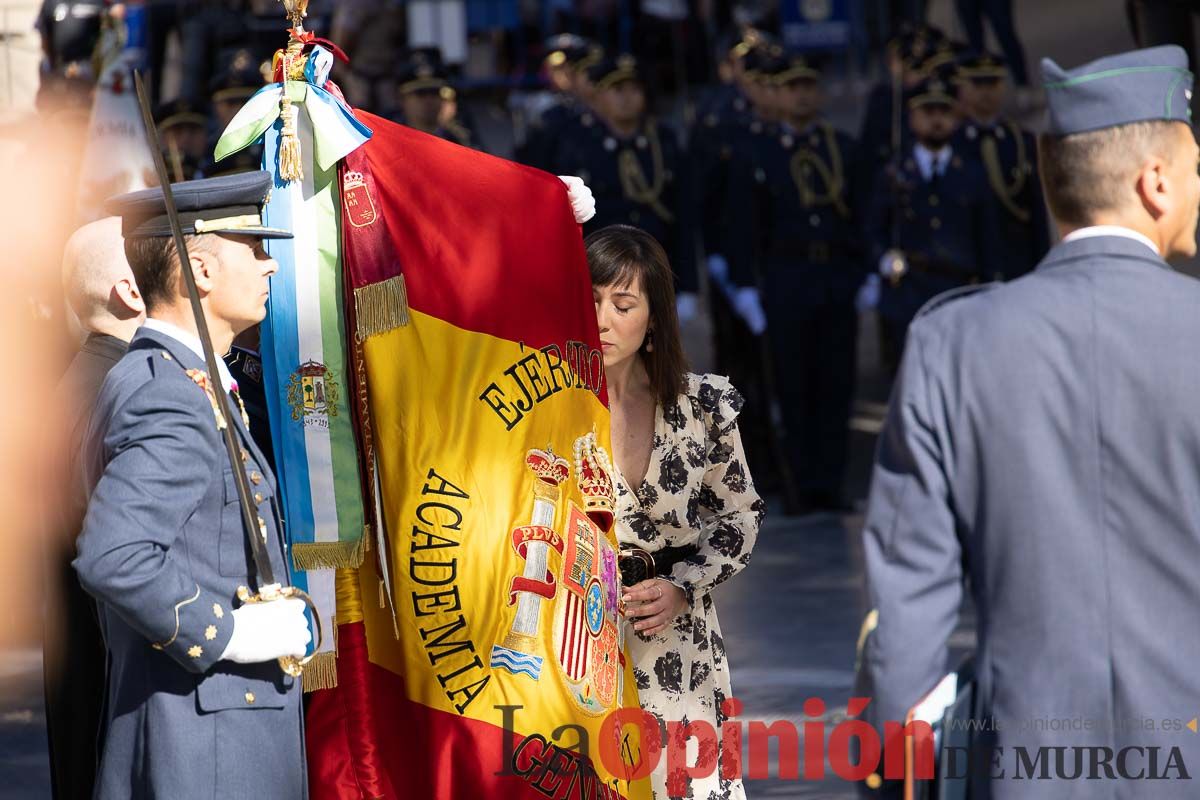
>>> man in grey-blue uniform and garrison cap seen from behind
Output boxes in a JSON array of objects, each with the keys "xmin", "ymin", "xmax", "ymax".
[{"xmin": 859, "ymin": 46, "xmax": 1200, "ymax": 800}]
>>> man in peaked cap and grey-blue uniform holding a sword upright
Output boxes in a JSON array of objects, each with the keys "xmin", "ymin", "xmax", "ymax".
[{"xmin": 74, "ymin": 172, "xmax": 310, "ymax": 800}]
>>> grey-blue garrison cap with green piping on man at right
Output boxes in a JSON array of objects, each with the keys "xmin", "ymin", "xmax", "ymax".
[{"xmin": 1042, "ymin": 44, "xmax": 1193, "ymax": 136}]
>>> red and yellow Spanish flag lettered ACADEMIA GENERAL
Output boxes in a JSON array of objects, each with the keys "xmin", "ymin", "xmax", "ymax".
[{"xmin": 307, "ymin": 112, "xmax": 650, "ymax": 800}]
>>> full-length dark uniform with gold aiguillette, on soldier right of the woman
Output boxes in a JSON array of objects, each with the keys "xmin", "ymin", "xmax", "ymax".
[{"xmin": 731, "ymin": 107, "xmax": 865, "ymax": 507}]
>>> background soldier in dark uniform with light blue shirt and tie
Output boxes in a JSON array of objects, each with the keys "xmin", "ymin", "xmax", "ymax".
[{"xmin": 866, "ymin": 78, "xmax": 1004, "ymax": 373}]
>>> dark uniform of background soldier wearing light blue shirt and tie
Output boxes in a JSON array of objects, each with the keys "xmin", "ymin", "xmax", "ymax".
[{"xmin": 868, "ymin": 130, "xmax": 1006, "ymax": 363}]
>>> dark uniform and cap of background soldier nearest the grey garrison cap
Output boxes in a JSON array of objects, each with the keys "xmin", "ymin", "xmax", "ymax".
[{"xmin": 953, "ymin": 55, "xmax": 1050, "ymax": 279}]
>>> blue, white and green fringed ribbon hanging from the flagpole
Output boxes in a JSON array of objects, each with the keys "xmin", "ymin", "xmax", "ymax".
[{"xmin": 216, "ymin": 46, "xmax": 371, "ymax": 691}]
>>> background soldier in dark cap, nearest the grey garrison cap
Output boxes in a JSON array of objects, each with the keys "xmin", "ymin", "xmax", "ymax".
[{"xmin": 954, "ymin": 53, "xmax": 1050, "ymax": 278}]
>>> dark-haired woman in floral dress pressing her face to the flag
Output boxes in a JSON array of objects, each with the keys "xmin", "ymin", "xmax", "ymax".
[{"xmin": 586, "ymin": 225, "xmax": 766, "ymax": 800}]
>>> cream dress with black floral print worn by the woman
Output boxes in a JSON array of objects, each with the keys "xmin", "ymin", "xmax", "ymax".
[{"xmin": 617, "ymin": 374, "xmax": 766, "ymax": 800}]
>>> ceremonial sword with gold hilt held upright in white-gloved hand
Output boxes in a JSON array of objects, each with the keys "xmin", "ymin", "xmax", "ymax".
[{"xmin": 133, "ymin": 71, "xmax": 323, "ymax": 678}]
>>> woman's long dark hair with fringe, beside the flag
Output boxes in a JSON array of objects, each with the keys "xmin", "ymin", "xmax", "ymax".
[{"xmin": 583, "ymin": 225, "xmax": 688, "ymax": 408}]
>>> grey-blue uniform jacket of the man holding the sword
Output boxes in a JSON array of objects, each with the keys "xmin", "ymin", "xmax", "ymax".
[{"xmin": 74, "ymin": 329, "xmax": 307, "ymax": 800}]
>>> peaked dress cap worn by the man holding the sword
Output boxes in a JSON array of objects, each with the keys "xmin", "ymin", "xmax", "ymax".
[{"xmin": 104, "ymin": 169, "xmax": 292, "ymax": 239}]
